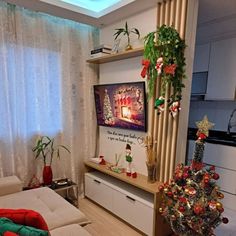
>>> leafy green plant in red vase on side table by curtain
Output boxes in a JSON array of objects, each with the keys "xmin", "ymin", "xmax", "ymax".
[{"xmin": 32, "ymin": 136, "xmax": 70, "ymax": 185}]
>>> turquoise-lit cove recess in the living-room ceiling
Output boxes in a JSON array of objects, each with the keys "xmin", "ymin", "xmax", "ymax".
[{"xmin": 40, "ymin": 0, "xmax": 135, "ymax": 18}]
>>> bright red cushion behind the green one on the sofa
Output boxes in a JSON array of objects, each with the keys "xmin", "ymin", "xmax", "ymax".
[{"xmin": 0, "ymin": 209, "xmax": 48, "ymax": 231}]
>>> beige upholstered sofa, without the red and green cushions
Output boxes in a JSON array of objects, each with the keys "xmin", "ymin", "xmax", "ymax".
[{"xmin": 0, "ymin": 176, "xmax": 90, "ymax": 236}]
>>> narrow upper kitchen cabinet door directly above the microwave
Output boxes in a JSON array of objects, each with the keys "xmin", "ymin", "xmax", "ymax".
[{"xmin": 193, "ymin": 43, "xmax": 210, "ymax": 73}]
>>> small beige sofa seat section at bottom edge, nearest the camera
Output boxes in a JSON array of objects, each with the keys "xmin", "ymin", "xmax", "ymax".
[{"xmin": 50, "ymin": 224, "xmax": 90, "ymax": 236}]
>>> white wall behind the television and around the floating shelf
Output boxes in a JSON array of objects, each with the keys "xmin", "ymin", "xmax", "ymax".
[{"xmin": 98, "ymin": 8, "xmax": 156, "ymax": 175}]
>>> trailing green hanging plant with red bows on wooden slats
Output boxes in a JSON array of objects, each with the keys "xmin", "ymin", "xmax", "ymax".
[{"xmin": 141, "ymin": 25, "xmax": 186, "ymax": 105}]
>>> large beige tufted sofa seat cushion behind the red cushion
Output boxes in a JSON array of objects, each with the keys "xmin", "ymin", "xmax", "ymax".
[{"xmin": 0, "ymin": 187, "xmax": 89, "ymax": 230}]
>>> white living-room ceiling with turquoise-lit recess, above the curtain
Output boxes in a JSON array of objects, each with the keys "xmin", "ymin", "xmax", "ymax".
[{"xmin": 4, "ymin": 0, "xmax": 161, "ymax": 27}]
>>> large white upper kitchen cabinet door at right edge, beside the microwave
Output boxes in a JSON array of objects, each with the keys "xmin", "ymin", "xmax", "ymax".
[{"xmin": 205, "ymin": 38, "xmax": 236, "ymax": 100}]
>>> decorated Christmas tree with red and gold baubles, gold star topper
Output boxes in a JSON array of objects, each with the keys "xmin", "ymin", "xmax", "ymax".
[{"xmin": 159, "ymin": 116, "xmax": 228, "ymax": 236}]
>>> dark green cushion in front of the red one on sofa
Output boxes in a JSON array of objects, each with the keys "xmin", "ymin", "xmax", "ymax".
[{"xmin": 0, "ymin": 218, "xmax": 48, "ymax": 236}]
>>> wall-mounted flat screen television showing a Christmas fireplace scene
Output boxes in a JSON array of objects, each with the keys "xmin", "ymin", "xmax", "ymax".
[{"xmin": 94, "ymin": 82, "xmax": 147, "ymax": 132}]
